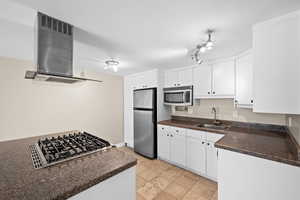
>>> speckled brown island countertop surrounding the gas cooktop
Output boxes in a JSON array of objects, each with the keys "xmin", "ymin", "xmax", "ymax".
[{"xmin": 0, "ymin": 131, "xmax": 137, "ymax": 200}]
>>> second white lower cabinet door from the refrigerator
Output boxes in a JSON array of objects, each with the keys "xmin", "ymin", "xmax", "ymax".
[{"xmin": 170, "ymin": 130, "xmax": 186, "ymax": 166}]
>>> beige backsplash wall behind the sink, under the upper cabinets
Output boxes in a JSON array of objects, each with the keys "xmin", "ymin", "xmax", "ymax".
[{"xmin": 172, "ymin": 99, "xmax": 286, "ymax": 125}]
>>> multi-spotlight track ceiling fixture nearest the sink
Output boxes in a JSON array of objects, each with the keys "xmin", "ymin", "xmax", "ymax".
[{"xmin": 191, "ymin": 29, "xmax": 214, "ymax": 64}]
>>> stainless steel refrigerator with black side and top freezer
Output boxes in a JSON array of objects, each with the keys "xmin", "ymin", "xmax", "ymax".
[{"xmin": 133, "ymin": 88, "xmax": 157, "ymax": 159}]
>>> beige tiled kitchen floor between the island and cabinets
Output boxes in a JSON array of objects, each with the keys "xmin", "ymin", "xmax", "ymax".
[{"xmin": 120, "ymin": 147, "xmax": 218, "ymax": 200}]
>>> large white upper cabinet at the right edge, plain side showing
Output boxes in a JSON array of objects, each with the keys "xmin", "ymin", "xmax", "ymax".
[{"xmin": 253, "ymin": 11, "xmax": 300, "ymax": 114}]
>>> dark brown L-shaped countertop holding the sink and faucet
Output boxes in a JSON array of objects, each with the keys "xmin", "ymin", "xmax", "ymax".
[{"xmin": 158, "ymin": 117, "xmax": 300, "ymax": 166}]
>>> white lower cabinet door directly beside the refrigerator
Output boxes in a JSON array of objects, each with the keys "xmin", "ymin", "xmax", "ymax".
[{"xmin": 157, "ymin": 125, "xmax": 170, "ymax": 160}]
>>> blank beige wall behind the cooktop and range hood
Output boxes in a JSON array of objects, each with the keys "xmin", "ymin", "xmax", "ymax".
[{"xmin": 0, "ymin": 57, "xmax": 123, "ymax": 143}]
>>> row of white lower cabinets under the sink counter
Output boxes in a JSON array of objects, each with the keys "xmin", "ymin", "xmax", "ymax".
[{"xmin": 158, "ymin": 125, "xmax": 223, "ymax": 181}]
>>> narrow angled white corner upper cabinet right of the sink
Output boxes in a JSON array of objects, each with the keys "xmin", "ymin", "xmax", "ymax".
[{"xmin": 235, "ymin": 52, "xmax": 253, "ymax": 108}]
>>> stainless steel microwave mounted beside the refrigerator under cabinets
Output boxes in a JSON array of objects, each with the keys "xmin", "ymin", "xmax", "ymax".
[{"xmin": 163, "ymin": 86, "xmax": 193, "ymax": 106}]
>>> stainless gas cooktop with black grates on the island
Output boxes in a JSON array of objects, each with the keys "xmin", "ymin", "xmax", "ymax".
[{"xmin": 30, "ymin": 132, "xmax": 112, "ymax": 168}]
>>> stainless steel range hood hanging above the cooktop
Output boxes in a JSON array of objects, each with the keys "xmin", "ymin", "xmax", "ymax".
[{"xmin": 25, "ymin": 12, "xmax": 102, "ymax": 83}]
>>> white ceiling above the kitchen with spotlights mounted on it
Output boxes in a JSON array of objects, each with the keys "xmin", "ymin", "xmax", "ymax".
[{"xmin": 4, "ymin": 0, "xmax": 300, "ymax": 74}]
